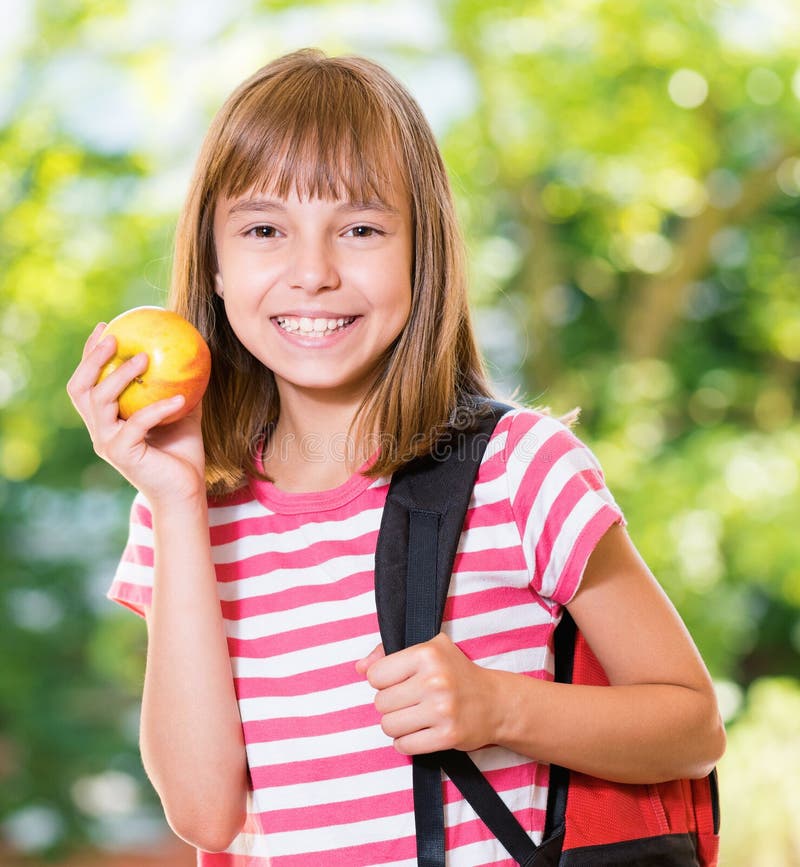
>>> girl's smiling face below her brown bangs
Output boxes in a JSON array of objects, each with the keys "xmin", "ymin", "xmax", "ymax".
[{"xmin": 214, "ymin": 175, "xmax": 412, "ymax": 412}]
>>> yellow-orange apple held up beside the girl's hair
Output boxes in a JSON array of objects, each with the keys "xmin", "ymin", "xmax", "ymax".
[{"xmin": 97, "ymin": 307, "xmax": 211, "ymax": 424}]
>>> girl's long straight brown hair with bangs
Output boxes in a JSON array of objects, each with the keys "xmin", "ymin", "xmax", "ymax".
[{"xmin": 170, "ymin": 49, "xmax": 490, "ymax": 494}]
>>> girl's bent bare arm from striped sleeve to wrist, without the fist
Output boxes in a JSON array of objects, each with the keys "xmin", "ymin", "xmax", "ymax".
[{"xmin": 484, "ymin": 525, "xmax": 725, "ymax": 783}]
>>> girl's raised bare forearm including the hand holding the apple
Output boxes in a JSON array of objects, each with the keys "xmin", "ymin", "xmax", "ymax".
[{"xmin": 67, "ymin": 327, "xmax": 248, "ymax": 851}]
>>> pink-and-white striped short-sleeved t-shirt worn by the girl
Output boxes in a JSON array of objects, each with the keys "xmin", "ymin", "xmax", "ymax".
[{"xmin": 109, "ymin": 410, "xmax": 622, "ymax": 867}]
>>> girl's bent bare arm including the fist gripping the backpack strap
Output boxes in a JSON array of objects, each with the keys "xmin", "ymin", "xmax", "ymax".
[{"xmin": 359, "ymin": 526, "xmax": 725, "ymax": 783}]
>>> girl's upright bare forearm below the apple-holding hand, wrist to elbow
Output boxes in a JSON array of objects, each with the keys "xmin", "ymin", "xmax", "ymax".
[{"xmin": 140, "ymin": 497, "xmax": 248, "ymax": 851}]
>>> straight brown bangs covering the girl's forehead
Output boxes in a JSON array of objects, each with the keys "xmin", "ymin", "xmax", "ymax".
[{"xmin": 218, "ymin": 65, "xmax": 408, "ymax": 203}]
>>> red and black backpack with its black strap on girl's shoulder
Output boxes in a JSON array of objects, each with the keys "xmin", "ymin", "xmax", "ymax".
[{"xmin": 375, "ymin": 400, "xmax": 719, "ymax": 867}]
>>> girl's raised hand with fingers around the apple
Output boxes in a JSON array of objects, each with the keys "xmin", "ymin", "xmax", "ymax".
[{"xmin": 67, "ymin": 322, "xmax": 205, "ymax": 506}]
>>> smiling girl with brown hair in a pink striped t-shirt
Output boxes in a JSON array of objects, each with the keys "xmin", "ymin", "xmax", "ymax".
[{"xmin": 68, "ymin": 51, "xmax": 724, "ymax": 867}]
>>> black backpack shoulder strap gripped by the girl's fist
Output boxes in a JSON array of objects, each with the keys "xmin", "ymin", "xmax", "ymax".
[{"xmin": 375, "ymin": 401, "xmax": 556, "ymax": 867}]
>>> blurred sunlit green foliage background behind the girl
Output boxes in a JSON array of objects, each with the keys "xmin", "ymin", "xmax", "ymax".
[{"xmin": 0, "ymin": 0, "xmax": 800, "ymax": 867}]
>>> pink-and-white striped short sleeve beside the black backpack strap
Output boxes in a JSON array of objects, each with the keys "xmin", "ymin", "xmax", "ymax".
[{"xmin": 505, "ymin": 410, "xmax": 625, "ymax": 605}]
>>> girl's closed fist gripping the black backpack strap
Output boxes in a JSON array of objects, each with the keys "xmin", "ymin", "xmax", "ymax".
[{"xmin": 356, "ymin": 632, "xmax": 500, "ymax": 755}]
